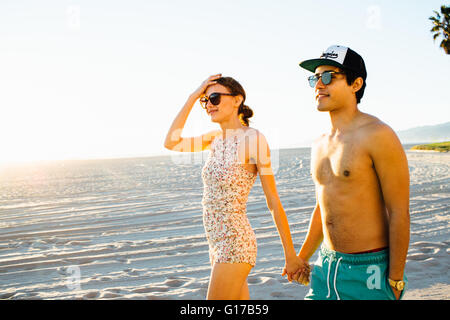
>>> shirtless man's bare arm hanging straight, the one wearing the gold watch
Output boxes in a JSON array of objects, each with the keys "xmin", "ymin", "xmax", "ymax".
[{"xmin": 369, "ymin": 125, "xmax": 410, "ymax": 298}]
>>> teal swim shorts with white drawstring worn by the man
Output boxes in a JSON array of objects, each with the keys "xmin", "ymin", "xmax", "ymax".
[{"xmin": 305, "ymin": 245, "xmax": 407, "ymax": 300}]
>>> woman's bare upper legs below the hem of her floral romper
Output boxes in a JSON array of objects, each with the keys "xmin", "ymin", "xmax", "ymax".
[{"xmin": 206, "ymin": 263, "xmax": 252, "ymax": 300}]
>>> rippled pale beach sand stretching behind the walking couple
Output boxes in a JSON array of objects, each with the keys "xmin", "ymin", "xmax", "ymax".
[{"xmin": 0, "ymin": 149, "xmax": 450, "ymax": 299}]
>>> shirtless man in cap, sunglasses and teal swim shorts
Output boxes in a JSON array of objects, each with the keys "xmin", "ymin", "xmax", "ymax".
[{"xmin": 294, "ymin": 46, "xmax": 409, "ymax": 299}]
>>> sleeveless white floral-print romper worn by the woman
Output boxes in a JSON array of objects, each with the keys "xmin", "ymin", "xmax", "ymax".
[{"xmin": 202, "ymin": 136, "xmax": 257, "ymax": 266}]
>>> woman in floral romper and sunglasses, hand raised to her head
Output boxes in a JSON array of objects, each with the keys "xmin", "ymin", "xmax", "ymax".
[{"xmin": 164, "ymin": 74, "xmax": 309, "ymax": 300}]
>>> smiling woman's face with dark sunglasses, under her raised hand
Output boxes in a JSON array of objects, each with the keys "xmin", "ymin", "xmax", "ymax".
[{"xmin": 205, "ymin": 83, "xmax": 239, "ymax": 123}]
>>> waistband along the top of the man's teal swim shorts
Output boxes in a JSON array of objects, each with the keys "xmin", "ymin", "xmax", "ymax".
[{"xmin": 320, "ymin": 245, "xmax": 389, "ymax": 265}]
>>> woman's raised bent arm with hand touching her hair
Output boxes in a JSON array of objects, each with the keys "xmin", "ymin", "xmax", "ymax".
[{"xmin": 164, "ymin": 74, "xmax": 221, "ymax": 152}]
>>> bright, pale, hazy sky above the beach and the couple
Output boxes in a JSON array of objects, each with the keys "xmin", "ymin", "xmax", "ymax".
[{"xmin": 0, "ymin": 0, "xmax": 450, "ymax": 162}]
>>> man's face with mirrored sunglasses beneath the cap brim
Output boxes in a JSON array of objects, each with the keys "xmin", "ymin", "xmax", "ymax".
[{"xmin": 314, "ymin": 66, "xmax": 355, "ymax": 111}]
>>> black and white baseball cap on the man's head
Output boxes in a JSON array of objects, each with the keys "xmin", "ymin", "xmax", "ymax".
[{"xmin": 299, "ymin": 45, "xmax": 367, "ymax": 80}]
